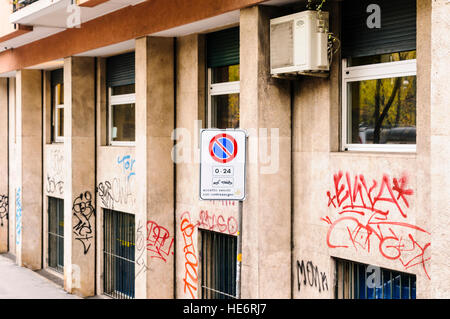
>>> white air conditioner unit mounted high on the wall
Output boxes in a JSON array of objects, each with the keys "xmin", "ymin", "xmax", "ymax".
[{"xmin": 270, "ymin": 10, "xmax": 329, "ymax": 76}]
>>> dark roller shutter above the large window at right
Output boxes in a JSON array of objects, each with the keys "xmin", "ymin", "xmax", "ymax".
[{"xmin": 341, "ymin": 0, "xmax": 416, "ymax": 57}]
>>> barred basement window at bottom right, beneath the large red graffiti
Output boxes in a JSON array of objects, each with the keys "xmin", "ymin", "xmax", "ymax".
[{"xmin": 335, "ymin": 259, "xmax": 416, "ymax": 299}]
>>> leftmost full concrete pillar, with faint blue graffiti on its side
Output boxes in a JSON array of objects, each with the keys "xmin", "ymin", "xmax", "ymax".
[{"xmin": 10, "ymin": 70, "xmax": 42, "ymax": 269}]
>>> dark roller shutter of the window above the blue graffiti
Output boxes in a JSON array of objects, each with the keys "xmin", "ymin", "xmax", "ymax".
[{"xmin": 106, "ymin": 52, "xmax": 136, "ymax": 86}]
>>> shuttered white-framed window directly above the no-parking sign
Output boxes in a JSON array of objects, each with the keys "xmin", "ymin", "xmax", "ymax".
[{"xmin": 206, "ymin": 28, "xmax": 240, "ymax": 129}]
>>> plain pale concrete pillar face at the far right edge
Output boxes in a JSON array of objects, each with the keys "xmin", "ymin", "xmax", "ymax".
[{"xmin": 428, "ymin": 0, "xmax": 450, "ymax": 298}]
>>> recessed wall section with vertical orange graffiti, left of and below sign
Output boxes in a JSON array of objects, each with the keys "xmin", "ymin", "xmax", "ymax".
[{"xmin": 173, "ymin": 34, "xmax": 243, "ymax": 299}]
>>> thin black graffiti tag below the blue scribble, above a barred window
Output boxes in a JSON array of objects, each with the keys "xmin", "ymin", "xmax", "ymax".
[{"xmin": 97, "ymin": 178, "xmax": 135, "ymax": 209}]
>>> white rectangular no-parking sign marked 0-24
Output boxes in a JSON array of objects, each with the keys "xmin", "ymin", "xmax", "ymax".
[{"xmin": 200, "ymin": 129, "xmax": 246, "ymax": 200}]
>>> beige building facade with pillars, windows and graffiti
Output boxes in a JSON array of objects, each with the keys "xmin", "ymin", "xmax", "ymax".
[{"xmin": 0, "ymin": 0, "xmax": 450, "ymax": 299}]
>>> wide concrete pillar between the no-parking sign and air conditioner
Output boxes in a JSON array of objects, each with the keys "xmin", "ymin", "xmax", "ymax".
[{"xmin": 240, "ymin": 7, "xmax": 291, "ymax": 298}]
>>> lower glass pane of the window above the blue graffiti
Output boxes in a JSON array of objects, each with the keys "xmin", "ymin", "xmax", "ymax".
[{"xmin": 111, "ymin": 103, "xmax": 135, "ymax": 141}]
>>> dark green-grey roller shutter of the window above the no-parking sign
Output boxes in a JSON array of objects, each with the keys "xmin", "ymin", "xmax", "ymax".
[{"xmin": 206, "ymin": 27, "xmax": 239, "ymax": 68}]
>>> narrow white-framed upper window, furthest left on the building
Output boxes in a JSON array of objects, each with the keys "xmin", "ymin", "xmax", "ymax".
[{"xmin": 51, "ymin": 69, "xmax": 64, "ymax": 143}]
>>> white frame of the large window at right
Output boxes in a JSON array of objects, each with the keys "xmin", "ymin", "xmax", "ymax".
[{"xmin": 341, "ymin": 58, "xmax": 417, "ymax": 153}]
